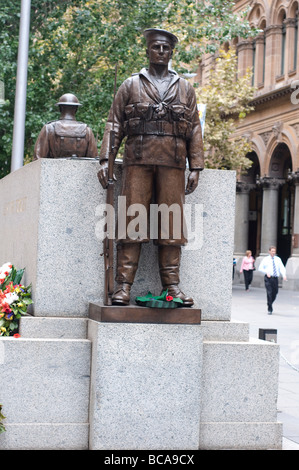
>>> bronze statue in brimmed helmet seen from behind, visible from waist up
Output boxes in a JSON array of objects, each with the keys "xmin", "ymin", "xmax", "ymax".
[{"xmin": 34, "ymin": 93, "xmax": 98, "ymax": 160}]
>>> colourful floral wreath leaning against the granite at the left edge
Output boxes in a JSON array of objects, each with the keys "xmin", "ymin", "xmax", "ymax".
[{"xmin": 0, "ymin": 263, "xmax": 32, "ymax": 337}]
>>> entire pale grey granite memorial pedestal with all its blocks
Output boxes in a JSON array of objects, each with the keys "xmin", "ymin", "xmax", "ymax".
[{"xmin": 0, "ymin": 160, "xmax": 282, "ymax": 450}]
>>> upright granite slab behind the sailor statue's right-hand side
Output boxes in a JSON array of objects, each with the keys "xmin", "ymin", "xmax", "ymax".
[{"xmin": 181, "ymin": 170, "xmax": 236, "ymax": 320}]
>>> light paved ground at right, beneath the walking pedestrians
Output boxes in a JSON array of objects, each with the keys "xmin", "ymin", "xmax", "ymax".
[{"xmin": 231, "ymin": 284, "xmax": 299, "ymax": 450}]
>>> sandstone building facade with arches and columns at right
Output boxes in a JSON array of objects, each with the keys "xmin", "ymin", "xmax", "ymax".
[{"xmin": 218, "ymin": 0, "xmax": 299, "ymax": 290}]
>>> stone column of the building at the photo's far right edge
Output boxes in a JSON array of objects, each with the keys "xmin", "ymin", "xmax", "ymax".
[{"xmin": 283, "ymin": 170, "xmax": 299, "ymax": 290}]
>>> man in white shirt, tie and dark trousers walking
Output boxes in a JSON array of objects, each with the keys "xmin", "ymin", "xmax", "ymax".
[{"xmin": 259, "ymin": 246, "xmax": 287, "ymax": 315}]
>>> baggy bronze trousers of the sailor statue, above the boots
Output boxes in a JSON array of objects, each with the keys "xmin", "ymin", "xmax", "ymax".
[{"xmin": 117, "ymin": 165, "xmax": 187, "ymax": 246}]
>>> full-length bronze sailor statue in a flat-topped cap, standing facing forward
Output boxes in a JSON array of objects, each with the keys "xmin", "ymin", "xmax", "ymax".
[{"xmin": 98, "ymin": 29, "xmax": 204, "ymax": 306}]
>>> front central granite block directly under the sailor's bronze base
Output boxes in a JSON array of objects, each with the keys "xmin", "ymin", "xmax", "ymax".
[{"xmin": 89, "ymin": 320, "xmax": 202, "ymax": 450}]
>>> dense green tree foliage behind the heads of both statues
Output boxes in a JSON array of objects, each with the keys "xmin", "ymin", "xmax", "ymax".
[{"xmin": 0, "ymin": 0, "xmax": 256, "ymax": 176}]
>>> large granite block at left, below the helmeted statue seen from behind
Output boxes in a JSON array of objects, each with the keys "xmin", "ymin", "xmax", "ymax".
[{"xmin": 0, "ymin": 159, "xmax": 104, "ymax": 317}]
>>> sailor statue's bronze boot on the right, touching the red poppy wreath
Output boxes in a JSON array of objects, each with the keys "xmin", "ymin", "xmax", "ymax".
[{"xmin": 158, "ymin": 245, "xmax": 194, "ymax": 307}]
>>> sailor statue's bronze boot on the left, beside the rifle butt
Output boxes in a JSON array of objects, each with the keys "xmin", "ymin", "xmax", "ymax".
[{"xmin": 112, "ymin": 243, "xmax": 141, "ymax": 305}]
